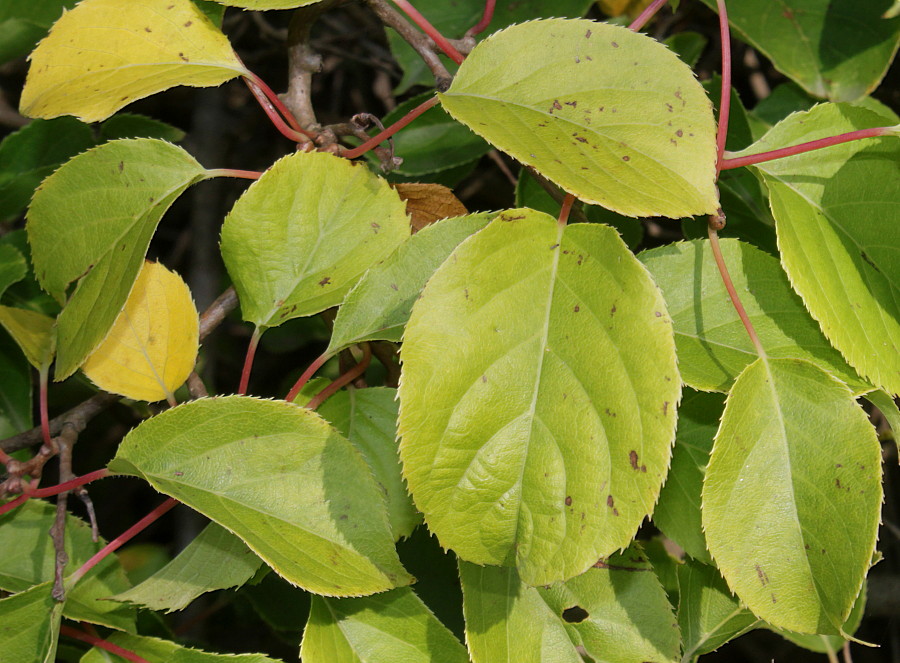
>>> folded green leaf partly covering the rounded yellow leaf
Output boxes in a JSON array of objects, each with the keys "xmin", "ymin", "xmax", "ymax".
[{"xmin": 26, "ymin": 138, "xmax": 206, "ymax": 380}]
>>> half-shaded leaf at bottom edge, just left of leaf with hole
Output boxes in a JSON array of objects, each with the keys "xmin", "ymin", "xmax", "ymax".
[{"xmin": 459, "ymin": 562, "xmax": 583, "ymax": 663}]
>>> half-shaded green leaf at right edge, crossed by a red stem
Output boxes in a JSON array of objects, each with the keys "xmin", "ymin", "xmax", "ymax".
[{"xmin": 742, "ymin": 104, "xmax": 900, "ymax": 394}]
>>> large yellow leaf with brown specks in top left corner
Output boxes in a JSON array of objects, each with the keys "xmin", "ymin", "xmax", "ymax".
[{"xmin": 20, "ymin": 0, "xmax": 247, "ymax": 122}]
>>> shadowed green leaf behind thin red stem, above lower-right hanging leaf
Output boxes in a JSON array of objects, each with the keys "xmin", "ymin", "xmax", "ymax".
[{"xmin": 640, "ymin": 239, "xmax": 871, "ymax": 393}]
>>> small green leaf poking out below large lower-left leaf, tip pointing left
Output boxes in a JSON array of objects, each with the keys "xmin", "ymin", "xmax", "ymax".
[{"xmin": 110, "ymin": 523, "xmax": 262, "ymax": 612}]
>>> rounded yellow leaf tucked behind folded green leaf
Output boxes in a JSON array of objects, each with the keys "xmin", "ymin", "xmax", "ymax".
[{"xmin": 81, "ymin": 261, "xmax": 200, "ymax": 401}]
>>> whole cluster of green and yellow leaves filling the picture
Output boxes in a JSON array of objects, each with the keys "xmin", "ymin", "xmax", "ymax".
[{"xmin": 0, "ymin": 0, "xmax": 900, "ymax": 663}]
